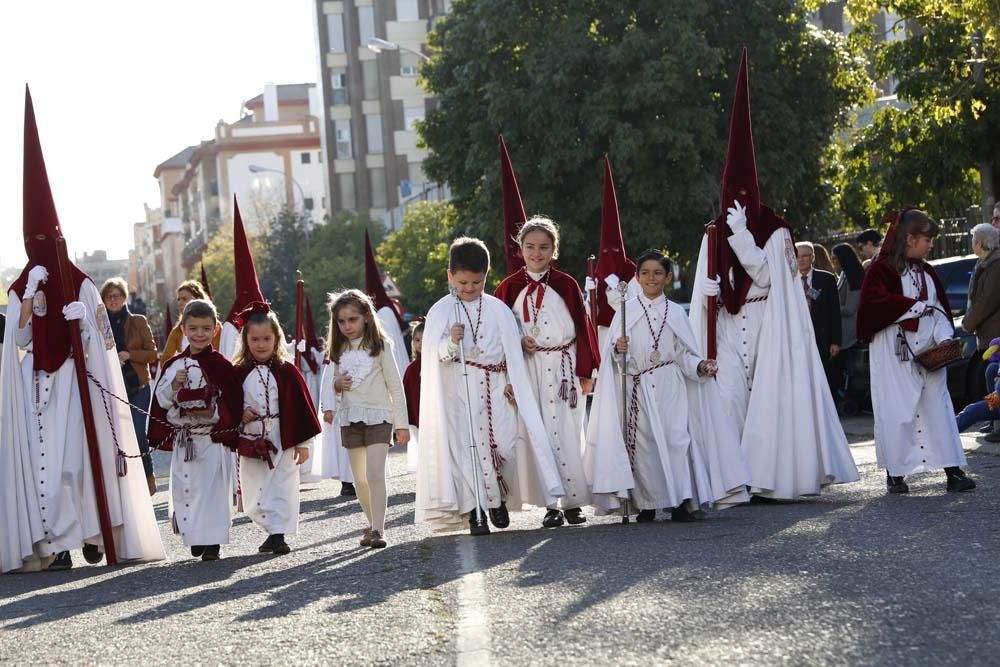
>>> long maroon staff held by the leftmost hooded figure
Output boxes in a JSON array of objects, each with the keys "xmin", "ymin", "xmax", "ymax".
[{"xmin": 53, "ymin": 236, "xmax": 119, "ymax": 565}]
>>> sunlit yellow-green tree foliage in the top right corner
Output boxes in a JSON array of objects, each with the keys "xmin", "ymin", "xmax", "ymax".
[{"xmin": 843, "ymin": 0, "xmax": 1000, "ymax": 221}]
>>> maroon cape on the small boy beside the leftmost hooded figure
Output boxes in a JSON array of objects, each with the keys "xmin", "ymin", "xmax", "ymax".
[{"xmin": 148, "ymin": 346, "xmax": 243, "ymax": 452}]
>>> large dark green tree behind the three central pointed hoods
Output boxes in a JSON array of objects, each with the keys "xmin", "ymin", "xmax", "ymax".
[{"xmin": 420, "ymin": 0, "xmax": 868, "ymax": 275}]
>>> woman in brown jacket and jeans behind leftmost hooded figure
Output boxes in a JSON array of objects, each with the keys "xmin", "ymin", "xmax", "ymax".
[{"xmin": 101, "ymin": 278, "xmax": 157, "ymax": 495}]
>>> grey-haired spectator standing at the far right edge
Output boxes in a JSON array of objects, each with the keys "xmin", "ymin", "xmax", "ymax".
[{"xmin": 962, "ymin": 223, "xmax": 1000, "ymax": 435}]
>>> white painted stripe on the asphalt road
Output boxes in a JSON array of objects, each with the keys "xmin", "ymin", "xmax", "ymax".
[{"xmin": 456, "ymin": 535, "xmax": 490, "ymax": 667}]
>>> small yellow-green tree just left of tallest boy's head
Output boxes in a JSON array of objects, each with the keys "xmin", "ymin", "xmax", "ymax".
[{"xmin": 376, "ymin": 202, "xmax": 459, "ymax": 313}]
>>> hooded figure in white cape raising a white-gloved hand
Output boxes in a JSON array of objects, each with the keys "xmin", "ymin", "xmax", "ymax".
[{"xmin": 691, "ymin": 48, "xmax": 858, "ymax": 499}]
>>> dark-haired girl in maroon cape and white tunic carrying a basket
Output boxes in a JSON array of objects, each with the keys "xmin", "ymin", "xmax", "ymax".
[{"xmin": 858, "ymin": 209, "xmax": 976, "ymax": 493}]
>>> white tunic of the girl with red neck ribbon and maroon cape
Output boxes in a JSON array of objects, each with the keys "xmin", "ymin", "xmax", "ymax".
[{"xmin": 513, "ymin": 273, "xmax": 590, "ymax": 509}]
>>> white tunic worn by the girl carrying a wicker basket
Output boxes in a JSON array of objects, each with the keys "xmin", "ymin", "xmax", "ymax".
[{"xmin": 869, "ymin": 271, "xmax": 965, "ymax": 476}]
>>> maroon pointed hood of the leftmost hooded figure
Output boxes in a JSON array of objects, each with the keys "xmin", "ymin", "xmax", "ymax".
[{"xmin": 9, "ymin": 86, "xmax": 88, "ymax": 373}]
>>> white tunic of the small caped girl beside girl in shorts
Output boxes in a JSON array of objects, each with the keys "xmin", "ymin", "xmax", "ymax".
[{"xmin": 239, "ymin": 366, "xmax": 312, "ymax": 535}]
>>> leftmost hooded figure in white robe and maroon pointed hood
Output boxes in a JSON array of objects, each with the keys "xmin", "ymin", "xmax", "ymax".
[{"xmin": 0, "ymin": 89, "xmax": 163, "ymax": 572}]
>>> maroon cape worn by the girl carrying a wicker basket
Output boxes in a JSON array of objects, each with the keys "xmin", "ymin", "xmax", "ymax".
[{"xmin": 857, "ymin": 255, "xmax": 951, "ymax": 342}]
